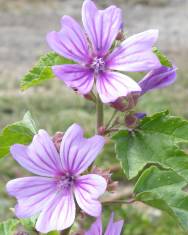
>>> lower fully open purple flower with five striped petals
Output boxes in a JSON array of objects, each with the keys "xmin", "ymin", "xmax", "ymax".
[{"xmin": 7, "ymin": 124, "xmax": 107, "ymax": 233}]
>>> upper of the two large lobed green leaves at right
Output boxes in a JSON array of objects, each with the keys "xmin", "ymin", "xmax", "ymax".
[{"xmin": 112, "ymin": 112, "xmax": 188, "ymax": 182}]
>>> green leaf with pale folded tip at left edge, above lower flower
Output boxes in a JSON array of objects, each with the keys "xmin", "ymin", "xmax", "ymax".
[{"xmin": 0, "ymin": 112, "xmax": 37, "ymax": 158}]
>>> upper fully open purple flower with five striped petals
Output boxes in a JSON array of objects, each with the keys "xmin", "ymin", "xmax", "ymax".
[{"xmin": 47, "ymin": 0, "xmax": 160, "ymax": 103}]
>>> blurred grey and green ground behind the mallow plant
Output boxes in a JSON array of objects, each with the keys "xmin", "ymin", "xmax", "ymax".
[{"xmin": 0, "ymin": 0, "xmax": 188, "ymax": 235}]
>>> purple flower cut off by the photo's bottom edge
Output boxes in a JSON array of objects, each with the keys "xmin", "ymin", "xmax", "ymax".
[{"xmin": 84, "ymin": 213, "xmax": 123, "ymax": 235}]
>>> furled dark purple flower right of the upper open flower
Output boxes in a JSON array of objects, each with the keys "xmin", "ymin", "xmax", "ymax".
[{"xmin": 139, "ymin": 66, "xmax": 177, "ymax": 95}]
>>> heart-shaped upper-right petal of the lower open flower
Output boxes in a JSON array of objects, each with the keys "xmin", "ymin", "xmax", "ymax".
[{"xmin": 60, "ymin": 124, "xmax": 105, "ymax": 174}]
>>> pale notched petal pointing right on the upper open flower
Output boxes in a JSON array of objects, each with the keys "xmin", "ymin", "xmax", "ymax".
[{"xmin": 106, "ymin": 30, "xmax": 161, "ymax": 72}]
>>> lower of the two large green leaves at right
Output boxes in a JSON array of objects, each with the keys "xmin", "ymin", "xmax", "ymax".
[{"xmin": 134, "ymin": 167, "xmax": 188, "ymax": 230}]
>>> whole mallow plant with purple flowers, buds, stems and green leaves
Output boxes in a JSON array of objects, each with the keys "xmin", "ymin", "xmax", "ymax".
[{"xmin": 0, "ymin": 0, "xmax": 188, "ymax": 235}]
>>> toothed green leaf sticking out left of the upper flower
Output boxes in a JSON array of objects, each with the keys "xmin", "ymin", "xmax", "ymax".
[{"xmin": 20, "ymin": 52, "xmax": 73, "ymax": 90}]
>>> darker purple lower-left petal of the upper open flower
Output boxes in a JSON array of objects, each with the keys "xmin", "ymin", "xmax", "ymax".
[{"xmin": 53, "ymin": 64, "xmax": 94, "ymax": 95}]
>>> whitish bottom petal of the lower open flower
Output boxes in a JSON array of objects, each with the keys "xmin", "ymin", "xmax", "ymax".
[{"xmin": 36, "ymin": 193, "xmax": 76, "ymax": 234}]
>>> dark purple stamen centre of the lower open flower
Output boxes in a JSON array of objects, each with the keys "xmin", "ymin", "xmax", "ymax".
[{"xmin": 57, "ymin": 175, "xmax": 75, "ymax": 191}]
